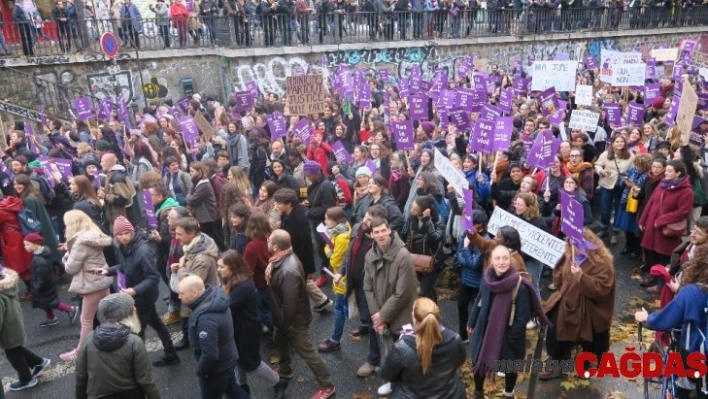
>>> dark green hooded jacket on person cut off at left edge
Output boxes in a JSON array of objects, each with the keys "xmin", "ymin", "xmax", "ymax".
[{"xmin": 0, "ymin": 268, "xmax": 25, "ymax": 349}]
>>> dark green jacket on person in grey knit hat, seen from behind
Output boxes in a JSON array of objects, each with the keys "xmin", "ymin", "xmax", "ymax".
[{"xmin": 76, "ymin": 323, "xmax": 160, "ymax": 399}]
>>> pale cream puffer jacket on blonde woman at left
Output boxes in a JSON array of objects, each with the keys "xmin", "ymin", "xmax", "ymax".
[{"xmin": 62, "ymin": 230, "xmax": 113, "ymax": 294}]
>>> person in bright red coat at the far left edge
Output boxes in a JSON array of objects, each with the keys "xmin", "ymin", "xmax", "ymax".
[{"xmin": 0, "ymin": 197, "xmax": 32, "ymax": 300}]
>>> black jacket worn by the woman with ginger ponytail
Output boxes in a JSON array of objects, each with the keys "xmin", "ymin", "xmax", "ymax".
[{"xmin": 381, "ymin": 329, "xmax": 467, "ymax": 399}]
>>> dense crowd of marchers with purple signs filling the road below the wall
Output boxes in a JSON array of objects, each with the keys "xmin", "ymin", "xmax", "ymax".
[{"xmin": 0, "ymin": 50, "xmax": 708, "ymax": 398}]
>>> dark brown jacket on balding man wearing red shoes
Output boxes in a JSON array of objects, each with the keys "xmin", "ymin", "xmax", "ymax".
[{"xmin": 270, "ymin": 252, "xmax": 312, "ymax": 330}]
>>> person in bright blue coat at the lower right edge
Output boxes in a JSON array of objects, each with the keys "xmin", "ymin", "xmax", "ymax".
[{"xmin": 634, "ymin": 244, "xmax": 708, "ymax": 399}]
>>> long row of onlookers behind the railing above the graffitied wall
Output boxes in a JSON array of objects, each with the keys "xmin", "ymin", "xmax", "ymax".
[{"xmin": 0, "ymin": 0, "xmax": 708, "ymax": 56}]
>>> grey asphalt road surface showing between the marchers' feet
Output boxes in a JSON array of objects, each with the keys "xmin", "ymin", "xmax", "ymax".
[{"xmin": 0, "ymin": 231, "xmax": 654, "ymax": 399}]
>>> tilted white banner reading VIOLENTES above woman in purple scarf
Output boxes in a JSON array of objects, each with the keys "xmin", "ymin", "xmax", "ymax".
[{"xmin": 487, "ymin": 207, "xmax": 565, "ymax": 268}]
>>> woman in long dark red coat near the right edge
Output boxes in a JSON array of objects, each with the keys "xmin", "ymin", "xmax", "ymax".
[{"xmin": 639, "ymin": 160, "xmax": 693, "ymax": 267}]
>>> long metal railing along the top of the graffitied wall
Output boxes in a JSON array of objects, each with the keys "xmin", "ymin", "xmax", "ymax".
[{"xmin": 0, "ymin": 3, "xmax": 708, "ymax": 57}]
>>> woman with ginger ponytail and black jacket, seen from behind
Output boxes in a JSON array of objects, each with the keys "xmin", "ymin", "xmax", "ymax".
[{"xmin": 381, "ymin": 297, "xmax": 466, "ymax": 399}]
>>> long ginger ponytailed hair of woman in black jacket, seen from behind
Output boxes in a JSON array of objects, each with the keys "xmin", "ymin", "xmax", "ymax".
[{"xmin": 413, "ymin": 297, "xmax": 442, "ymax": 375}]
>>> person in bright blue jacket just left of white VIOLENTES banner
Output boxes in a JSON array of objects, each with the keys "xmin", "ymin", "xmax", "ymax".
[{"xmin": 456, "ymin": 210, "xmax": 491, "ymax": 343}]
